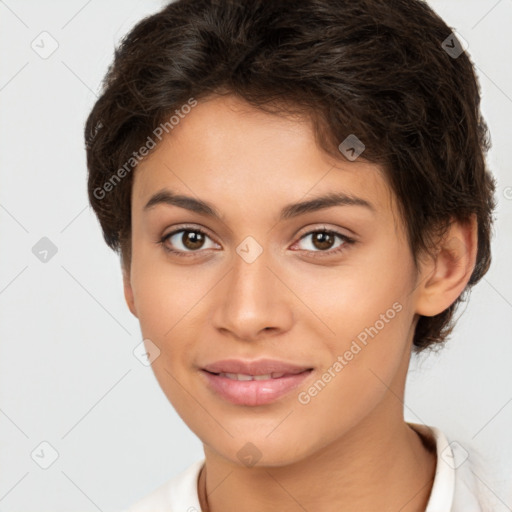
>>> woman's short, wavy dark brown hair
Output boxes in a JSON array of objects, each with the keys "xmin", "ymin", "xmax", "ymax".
[{"xmin": 85, "ymin": 0, "xmax": 495, "ymax": 352}]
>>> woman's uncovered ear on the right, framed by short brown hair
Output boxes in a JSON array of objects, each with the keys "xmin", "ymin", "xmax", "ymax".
[{"xmin": 415, "ymin": 214, "xmax": 478, "ymax": 316}]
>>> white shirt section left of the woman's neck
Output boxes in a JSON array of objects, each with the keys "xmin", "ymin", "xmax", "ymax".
[{"xmin": 123, "ymin": 459, "xmax": 204, "ymax": 512}]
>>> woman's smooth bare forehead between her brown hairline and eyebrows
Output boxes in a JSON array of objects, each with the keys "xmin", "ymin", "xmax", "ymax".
[{"xmin": 132, "ymin": 96, "xmax": 392, "ymax": 220}]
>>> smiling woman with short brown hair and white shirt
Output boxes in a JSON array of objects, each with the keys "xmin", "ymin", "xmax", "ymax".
[{"xmin": 85, "ymin": 0, "xmax": 500, "ymax": 512}]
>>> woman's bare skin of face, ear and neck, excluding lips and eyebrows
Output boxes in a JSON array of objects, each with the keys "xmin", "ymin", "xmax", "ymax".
[{"xmin": 124, "ymin": 96, "xmax": 477, "ymax": 512}]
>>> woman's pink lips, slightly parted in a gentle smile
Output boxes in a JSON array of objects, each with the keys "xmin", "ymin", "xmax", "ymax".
[{"xmin": 201, "ymin": 359, "xmax": 313, "ymax": 406}]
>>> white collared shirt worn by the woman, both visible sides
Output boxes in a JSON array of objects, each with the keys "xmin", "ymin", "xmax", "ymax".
[{"xmin": 124, "ymin": 423, "xmax": 497, "ymax": 512}]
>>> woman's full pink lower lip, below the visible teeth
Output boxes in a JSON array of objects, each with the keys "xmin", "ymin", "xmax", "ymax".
[{"xmin": 201, "ymin": 370, "xmax": 312, "ymax": 405}]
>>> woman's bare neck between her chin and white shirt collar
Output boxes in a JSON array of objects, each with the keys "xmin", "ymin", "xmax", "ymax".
[{"xmin": 198, "ymin": 410, "xmax": 436, "ymax": 512}]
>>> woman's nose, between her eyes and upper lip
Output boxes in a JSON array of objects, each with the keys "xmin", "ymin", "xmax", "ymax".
[{"xmin": 213, "ymin": 242, "xmax": 294, "ymax": 341}]
